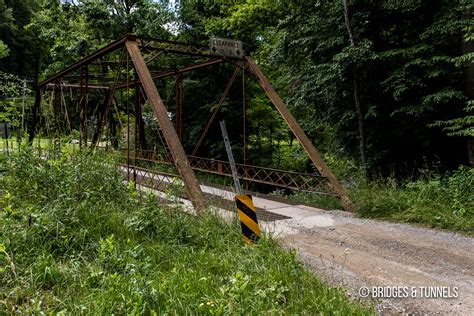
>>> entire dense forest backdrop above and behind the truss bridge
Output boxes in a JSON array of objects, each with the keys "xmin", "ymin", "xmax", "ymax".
[{"xmin": 0, "ymin": 0, "xmax": 474, "ymax": 175}]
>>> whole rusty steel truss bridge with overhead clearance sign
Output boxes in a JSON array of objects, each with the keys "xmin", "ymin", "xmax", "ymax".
[{"xmin": 30, "ymin": 35, "xmax": 355, "ymax": 211}]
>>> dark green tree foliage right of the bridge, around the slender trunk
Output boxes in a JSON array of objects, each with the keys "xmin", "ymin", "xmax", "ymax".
[{"xmin": 206, "ymin": 1, "xmax": 472, "ymax": 171}]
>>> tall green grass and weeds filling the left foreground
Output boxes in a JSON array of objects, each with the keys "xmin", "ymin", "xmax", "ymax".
[{"xmin": 0, "ymin": 148, "xmax": 373, "ymax": 315}]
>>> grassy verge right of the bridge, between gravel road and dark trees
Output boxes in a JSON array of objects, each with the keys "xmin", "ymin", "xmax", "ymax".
[{"xmin": 350, "ymin": 167, "xmax": 474, "ymax": 234}]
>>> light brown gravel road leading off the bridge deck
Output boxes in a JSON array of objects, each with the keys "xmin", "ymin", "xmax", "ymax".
[{"xmin": 271, "ymin": 206, "xmax": 474, "ymax": 315}]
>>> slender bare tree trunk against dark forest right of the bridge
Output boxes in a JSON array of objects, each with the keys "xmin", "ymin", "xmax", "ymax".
[{"xmin": 342, "ymin": 0, "xmax": 367, "ymax": 170}]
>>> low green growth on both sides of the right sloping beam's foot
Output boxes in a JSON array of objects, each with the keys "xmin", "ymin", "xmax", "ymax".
[{"xmin": 272, "ymin": 151, "xmax": 474, "ymax": 235}]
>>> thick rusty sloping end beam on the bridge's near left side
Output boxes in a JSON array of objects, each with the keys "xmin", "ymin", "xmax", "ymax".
[{"xmin": 125, "ymin": 40, "xmax": 206, "ymax": 213}]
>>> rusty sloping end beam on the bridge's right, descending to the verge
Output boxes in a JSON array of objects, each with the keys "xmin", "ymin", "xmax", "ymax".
[{"xmin": 245, "ymin": 56, "xmax": 356, "ymax": 212}]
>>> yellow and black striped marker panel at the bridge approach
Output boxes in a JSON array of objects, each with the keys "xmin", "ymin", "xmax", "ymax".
[{"xmin": 235, "ymin": 194, "xmax": 260, "ymax": 244}]
